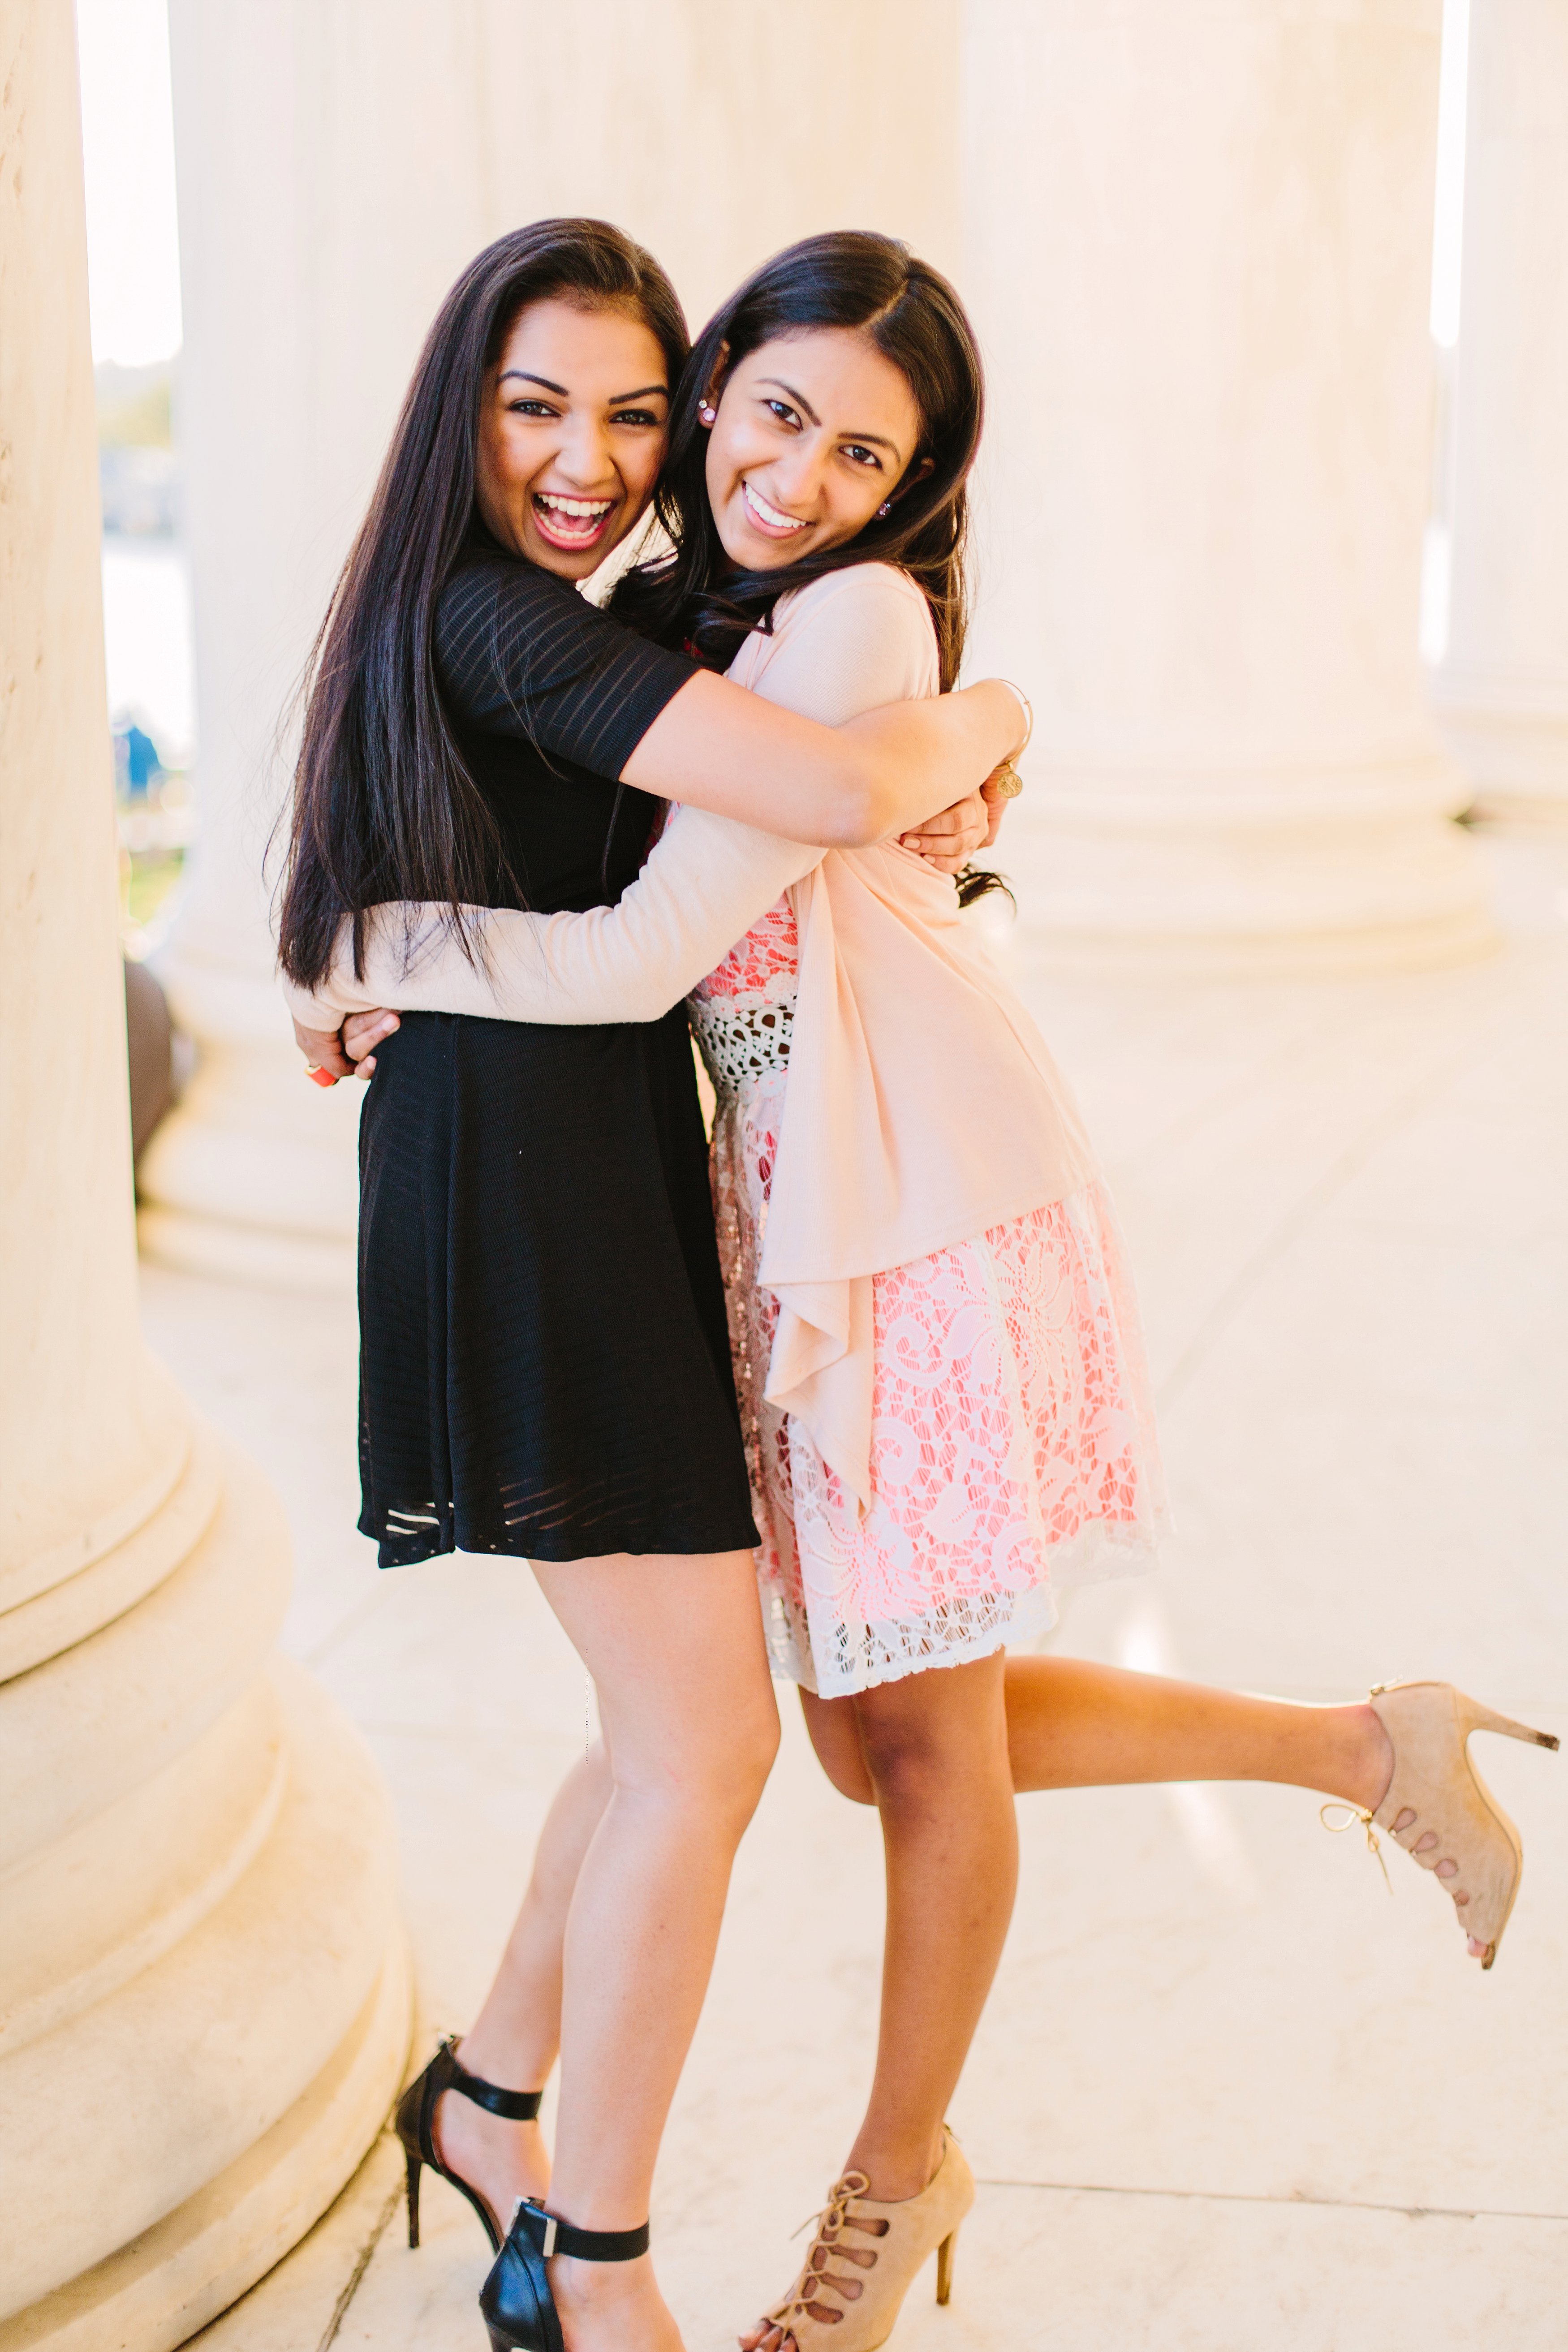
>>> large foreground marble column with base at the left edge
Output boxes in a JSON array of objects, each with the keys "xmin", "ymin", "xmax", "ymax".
[{"xmin": 0, "ymin": 0, "xmax": 409, "ymax": 2352}]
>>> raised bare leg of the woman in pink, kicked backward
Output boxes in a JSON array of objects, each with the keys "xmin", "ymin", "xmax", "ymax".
[{"xmin": 801, "ymin": 1658, "xmax": 1394, "ymax": 1809}]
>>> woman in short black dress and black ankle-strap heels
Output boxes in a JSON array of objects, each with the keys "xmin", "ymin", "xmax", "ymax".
[{"xmin": 282, "ymin": 221, "xmax": 1023, "ymax": 2352}]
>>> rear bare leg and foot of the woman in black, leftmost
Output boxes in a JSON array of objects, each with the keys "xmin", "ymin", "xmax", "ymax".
[{"xmin": 435, "ymin": 1740, "xmax": 611, "ymax": 2225}]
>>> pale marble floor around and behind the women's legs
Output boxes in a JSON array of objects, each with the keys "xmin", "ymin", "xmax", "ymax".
[{"xmin": 146, "ymin": 840, "xmax": 1568, "ymax": 2352}]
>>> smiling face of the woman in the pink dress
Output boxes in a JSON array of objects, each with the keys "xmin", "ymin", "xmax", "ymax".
[{"xmin": 707, "ymin": 327, "xmax": 929, "ymax": 572}]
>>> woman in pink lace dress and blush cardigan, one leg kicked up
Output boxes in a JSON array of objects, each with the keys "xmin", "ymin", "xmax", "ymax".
[{"xmin": 296, "ymin": 235, "xmax": 1556, "ymax": 2352}]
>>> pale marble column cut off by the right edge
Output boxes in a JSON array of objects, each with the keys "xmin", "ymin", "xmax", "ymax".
[{"xmin": 1432, "ymin": 0, "xmax": 1568, "ymax": 826}]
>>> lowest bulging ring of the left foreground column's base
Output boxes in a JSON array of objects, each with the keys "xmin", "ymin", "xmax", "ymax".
[{"xmin": 0, "ymin": 1661, "xmax": 411, "ymax": 2352}]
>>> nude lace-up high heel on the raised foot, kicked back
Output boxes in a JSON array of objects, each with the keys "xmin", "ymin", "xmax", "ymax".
[{"xmin": 1323, "ymin": 1682, "xmax": 1556, "ymax": 1969}]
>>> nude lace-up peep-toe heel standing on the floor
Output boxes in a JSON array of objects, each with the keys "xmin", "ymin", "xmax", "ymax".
[{"xmin": 767, "ymin": 2124, "xmax": 976, "ymax": 2352}]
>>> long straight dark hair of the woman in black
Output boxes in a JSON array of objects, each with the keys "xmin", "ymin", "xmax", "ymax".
[{"xmin": 280, "ymin": 221, "xmax": 689, "ymax": 988}]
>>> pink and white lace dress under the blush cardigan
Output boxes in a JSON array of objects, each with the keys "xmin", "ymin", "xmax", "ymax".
[{"xmin": 689, "ymin": 899, "xmax": 1163, "ymax": 1698}]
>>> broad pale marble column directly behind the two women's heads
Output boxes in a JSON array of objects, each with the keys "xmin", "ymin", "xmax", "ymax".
[{"xmin": 141, "ymin": 0, "xmax": 957, "ymax": 1284}]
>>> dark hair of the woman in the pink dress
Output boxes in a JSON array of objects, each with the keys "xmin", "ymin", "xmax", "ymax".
[{"xmin": 611, "ymin": 228, "xmax": 985, "ymax": 687}]
